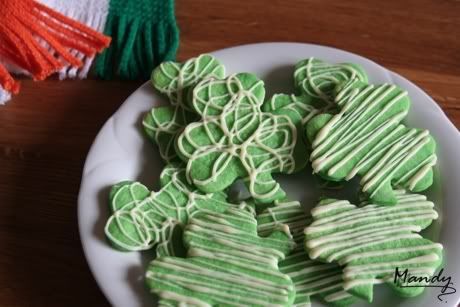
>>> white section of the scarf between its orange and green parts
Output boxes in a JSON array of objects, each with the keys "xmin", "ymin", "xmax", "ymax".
[{"xmin": 38, "ymin": 0, "xmax": 109, "ymax": 80}]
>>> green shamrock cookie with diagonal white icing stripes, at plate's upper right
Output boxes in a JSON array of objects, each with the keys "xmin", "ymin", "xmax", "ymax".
[{"xmin": 307, "ymin": 82, "xmax": 436, "ymax": 204}]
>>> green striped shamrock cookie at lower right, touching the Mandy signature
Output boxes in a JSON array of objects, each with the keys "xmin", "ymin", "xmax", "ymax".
[{"xmin": 305, "ymin": 191, "xmax": 442, "ymax": 302}]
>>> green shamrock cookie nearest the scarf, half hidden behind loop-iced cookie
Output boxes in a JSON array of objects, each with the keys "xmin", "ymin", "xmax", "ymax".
[{"xmin": 143, "ymin": 54, "xmax": 225, "ymax": 162}]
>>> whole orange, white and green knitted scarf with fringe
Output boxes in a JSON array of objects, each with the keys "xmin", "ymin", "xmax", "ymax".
[{"xmin": 0, "ymin": 0, "xmax": 179, "ymax": 104}]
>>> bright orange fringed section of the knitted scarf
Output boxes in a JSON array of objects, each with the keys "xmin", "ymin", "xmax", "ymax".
[{"xmin": 0, "ymin": 0, "xmax": 110, "ymax": 93}]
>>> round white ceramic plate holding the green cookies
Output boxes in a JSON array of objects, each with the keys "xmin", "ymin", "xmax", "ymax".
[{"xmin": 78, "ymin": 43, "xmax": 460, "ymax": 307}]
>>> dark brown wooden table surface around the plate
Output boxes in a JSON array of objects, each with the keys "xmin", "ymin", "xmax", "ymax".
[{"xmin": 0, "ymin": 0, "xmax": 460, "ymax": 307}]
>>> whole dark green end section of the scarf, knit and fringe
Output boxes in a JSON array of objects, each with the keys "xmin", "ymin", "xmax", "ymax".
[{"xmin": 94, "ymin": 0, "xmax": 179, "ymax": 80}]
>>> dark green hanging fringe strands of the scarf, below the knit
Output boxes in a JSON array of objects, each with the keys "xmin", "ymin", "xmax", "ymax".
[{"xmin": 94, "ymin": 14, "xmax": 179, "ymax": 80}]
